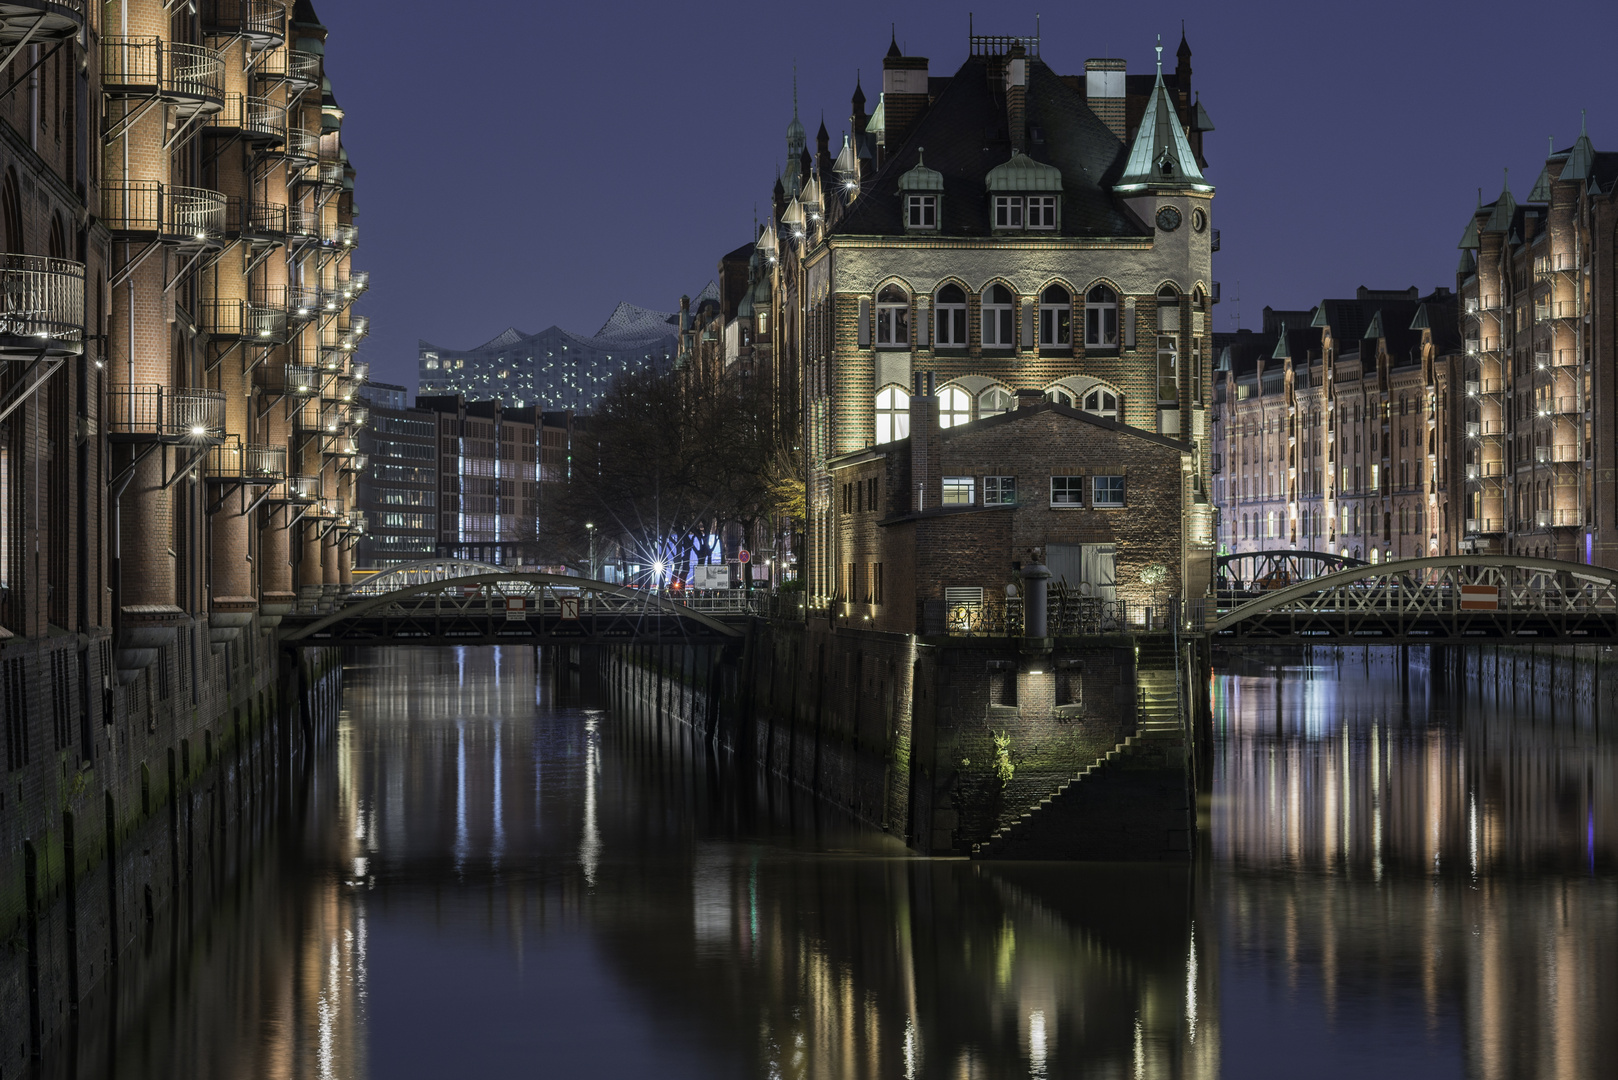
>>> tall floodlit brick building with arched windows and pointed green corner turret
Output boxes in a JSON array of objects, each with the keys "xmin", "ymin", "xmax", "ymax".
[{"xmin": 754, "ymin": 36, "xmax": 1215, "ymax": 610}]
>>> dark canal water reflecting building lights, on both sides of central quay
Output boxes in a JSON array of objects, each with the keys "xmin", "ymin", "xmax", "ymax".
[{"xmin": 47, "ymin": 649, "xmax": 1618, "ymax": 1080}]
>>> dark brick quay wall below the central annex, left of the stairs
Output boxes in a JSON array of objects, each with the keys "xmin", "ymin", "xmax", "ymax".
[{"xmin": 588, "ymin": 619, "xmax": 1194, "ymax": 858}]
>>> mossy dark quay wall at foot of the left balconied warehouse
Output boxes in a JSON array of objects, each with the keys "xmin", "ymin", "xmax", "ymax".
[{"xmin": 0, "ymin": 619, "xmax": 341, "ymax": 1077}]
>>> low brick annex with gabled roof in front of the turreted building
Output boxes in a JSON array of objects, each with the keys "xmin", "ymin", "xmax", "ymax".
[{"xmin": 828, "ymin": 390, "xmax": 1196, "ymax": 633}]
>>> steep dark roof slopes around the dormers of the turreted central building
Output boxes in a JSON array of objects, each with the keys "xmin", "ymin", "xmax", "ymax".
[{"xmin": 830, "ymin": 57, "xmax": 1150, "ymax": 236}]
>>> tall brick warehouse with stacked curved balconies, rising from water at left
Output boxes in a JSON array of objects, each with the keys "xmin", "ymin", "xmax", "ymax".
[{"xmin": 0, "ymin": 0, "xmax": 366, "ymax": 1075}]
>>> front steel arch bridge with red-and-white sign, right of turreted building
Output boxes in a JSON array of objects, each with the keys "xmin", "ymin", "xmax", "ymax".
[{"xmin": 1209, "ymin": 555, "xmax": 1618, "ymax": 644}]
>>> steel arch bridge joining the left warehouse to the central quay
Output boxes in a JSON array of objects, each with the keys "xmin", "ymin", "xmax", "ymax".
[{"xmin": 278, "ymin": 560, "xmax": 743, "ymax": 646}]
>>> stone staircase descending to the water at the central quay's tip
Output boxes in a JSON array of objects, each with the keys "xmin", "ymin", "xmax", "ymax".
[{"xmin": 972, "ymin": 635, "xmax": 1196, "ymax": 860}]
